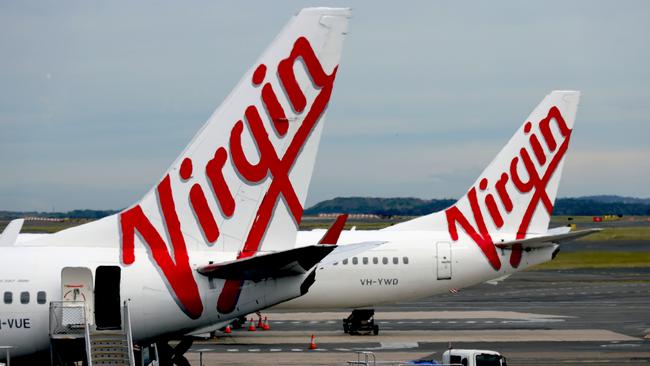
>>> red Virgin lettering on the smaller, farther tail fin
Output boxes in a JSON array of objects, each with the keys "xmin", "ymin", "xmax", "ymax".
[{"xmin": 445, "ymin": 106, "xmax": 572, "ymax": 270}]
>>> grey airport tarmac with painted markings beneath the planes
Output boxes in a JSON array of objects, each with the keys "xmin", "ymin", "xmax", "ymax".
[{"xmin": 188, "ymin": 268, "xmax": 650, "ymax": 365}]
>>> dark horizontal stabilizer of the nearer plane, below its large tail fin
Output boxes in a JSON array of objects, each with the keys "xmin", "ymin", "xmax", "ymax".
[{"xmin": 198, "ymin": 245, "xmax": 336, "ymax": 281}]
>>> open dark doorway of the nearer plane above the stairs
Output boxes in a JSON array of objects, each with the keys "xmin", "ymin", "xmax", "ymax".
[{"xmin": 95, "ymin": 266, "xmax": 122, "ymax": 329}]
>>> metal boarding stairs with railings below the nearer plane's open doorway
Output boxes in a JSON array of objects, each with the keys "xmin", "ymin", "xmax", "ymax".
[{"xmin": 50, "ymin": 301, "xmax": 135, "ymax": 366}]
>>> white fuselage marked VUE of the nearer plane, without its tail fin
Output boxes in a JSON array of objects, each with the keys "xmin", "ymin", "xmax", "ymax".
[{"xmin": 0, "ymin": 246, "xmax": 302, "ymax": 356}]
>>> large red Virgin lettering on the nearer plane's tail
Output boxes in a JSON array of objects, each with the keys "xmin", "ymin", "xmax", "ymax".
[{"xmin": 120, "ymin": 37, "xmax": 338, "ymax": 319}]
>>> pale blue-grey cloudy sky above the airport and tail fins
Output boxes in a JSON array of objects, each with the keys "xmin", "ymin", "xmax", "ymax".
[{"xmin": 0, "ymin": 0, "xmax": 650, "ymax": 211}]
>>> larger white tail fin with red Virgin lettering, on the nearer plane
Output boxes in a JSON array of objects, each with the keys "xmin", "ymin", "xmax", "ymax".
[{"xmin": 31, "ymin": 8, "xmax": 351, "ymax": 318}]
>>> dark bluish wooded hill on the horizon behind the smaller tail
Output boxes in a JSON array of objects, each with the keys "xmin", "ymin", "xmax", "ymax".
[{"xmin": 305, "ymin": 195, "xmax": 650, "ymax": 216}]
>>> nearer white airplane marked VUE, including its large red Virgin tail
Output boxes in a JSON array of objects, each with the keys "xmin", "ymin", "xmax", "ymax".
[{"xmin": 0, "ymin": 8, "xmax": 350, "ymax": 357}]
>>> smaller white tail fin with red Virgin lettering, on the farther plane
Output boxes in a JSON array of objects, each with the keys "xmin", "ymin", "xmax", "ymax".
[{"xmin": 386, "ymin": 91, "xmax": 580, "ymax": 240}]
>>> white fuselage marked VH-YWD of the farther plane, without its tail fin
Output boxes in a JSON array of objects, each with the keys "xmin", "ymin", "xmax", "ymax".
[{"xmin": 275, "ymin": 230, "xmax": 557, "ymax": 309}]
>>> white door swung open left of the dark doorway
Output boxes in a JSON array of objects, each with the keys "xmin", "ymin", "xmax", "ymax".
[{"xmin": 61, "ymin": 267, "xmax": 94, "ymax": 324}]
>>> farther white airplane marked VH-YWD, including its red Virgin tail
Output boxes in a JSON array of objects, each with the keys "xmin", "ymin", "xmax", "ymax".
[{"xmin": 278, "ymin": 91, "xmax": 594, "ymax": 315}]
